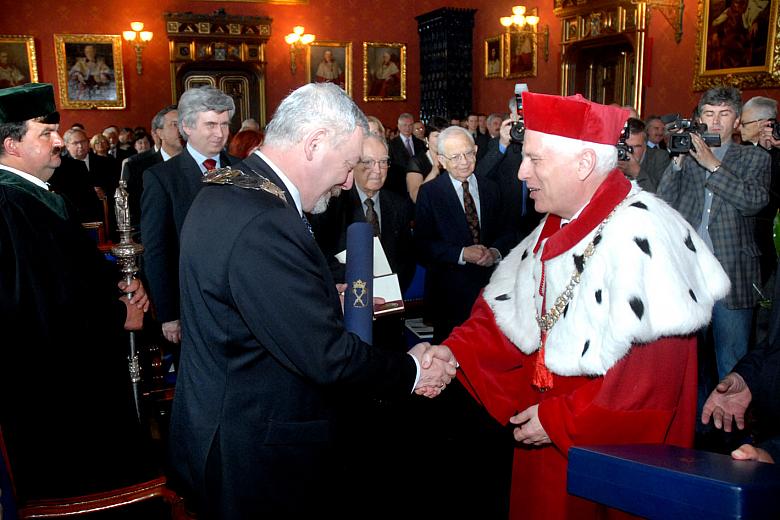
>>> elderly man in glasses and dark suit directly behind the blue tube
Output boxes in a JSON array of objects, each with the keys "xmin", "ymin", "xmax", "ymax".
[{"xmin": 312, "ymin": 135, "xmax": 416, "ymax": 291}]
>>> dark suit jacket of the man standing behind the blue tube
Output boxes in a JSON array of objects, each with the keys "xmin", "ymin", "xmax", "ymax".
[{"xmin": 309, "ymin": 186, "xmax": 416, "ymax": 292}]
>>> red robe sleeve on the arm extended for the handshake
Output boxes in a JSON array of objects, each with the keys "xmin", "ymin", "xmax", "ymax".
[{"xmin": 444, "ymin": 296, "xmax": 533, "ymax": 424}]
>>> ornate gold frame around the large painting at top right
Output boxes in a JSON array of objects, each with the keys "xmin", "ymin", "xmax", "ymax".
[{"xmin": 693, "ymin": 0, "xmax": 780, "ymax": 91}]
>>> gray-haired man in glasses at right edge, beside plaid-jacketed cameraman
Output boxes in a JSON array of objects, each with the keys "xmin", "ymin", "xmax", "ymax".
[{"xmin": 739, "ymin": 96, "xmax": 780, "ymax": 285}]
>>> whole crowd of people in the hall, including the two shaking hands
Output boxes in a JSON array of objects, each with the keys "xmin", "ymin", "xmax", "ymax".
[{"xmin": 0, "ymin": 78, "xmax": 780, "ymax": 519}]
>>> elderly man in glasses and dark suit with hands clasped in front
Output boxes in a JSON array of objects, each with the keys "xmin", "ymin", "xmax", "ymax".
[{"xmin": 415, "ymin": 127, "xmax": 509, "ymax": 343}]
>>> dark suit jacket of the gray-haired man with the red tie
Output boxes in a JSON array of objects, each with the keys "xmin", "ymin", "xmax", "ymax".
[{"xmin": 141, "ymin": 148, "xmax": 233, "ymax": 323}]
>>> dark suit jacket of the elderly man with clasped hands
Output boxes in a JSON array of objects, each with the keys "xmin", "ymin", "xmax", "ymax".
[{"xmin": 414, "ymin": 173, "xmax": 510, "ymax": 341}]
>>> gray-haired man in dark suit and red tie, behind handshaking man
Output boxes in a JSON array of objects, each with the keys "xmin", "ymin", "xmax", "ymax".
[{"xmin": 141, "ymin": 87, "xmax": 235, "ymax": 343}]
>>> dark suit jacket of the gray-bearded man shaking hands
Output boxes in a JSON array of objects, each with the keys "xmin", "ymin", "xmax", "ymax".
[{"xmin": 170, "ymin": 155, "xmax": 415, "ymax": 520}]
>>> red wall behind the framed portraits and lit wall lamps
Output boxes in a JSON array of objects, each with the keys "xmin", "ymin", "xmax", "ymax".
[{"xmin": 0, "ymin": 0, "xmax": 780, "ymax": 133}]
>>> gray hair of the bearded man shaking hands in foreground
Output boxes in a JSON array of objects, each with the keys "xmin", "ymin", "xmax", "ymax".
[{"xmin": 264, "ymin": 83, "xmax": 368, "ymax": 148}]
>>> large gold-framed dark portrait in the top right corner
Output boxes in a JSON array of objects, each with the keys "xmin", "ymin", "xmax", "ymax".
[{"xmin": 693, "ymin": 0, "xmax": 780, "ymax": 90}]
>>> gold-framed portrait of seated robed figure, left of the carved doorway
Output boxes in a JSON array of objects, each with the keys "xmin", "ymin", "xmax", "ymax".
[{"xmin": 54, "ymin": 34, "xmax": 125, "ymax": 109}]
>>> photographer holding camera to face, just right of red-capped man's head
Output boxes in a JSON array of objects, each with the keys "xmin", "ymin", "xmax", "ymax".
[{"xmin": 617, "ymin": 117, "xmax": 670, "ymax": 193}]
